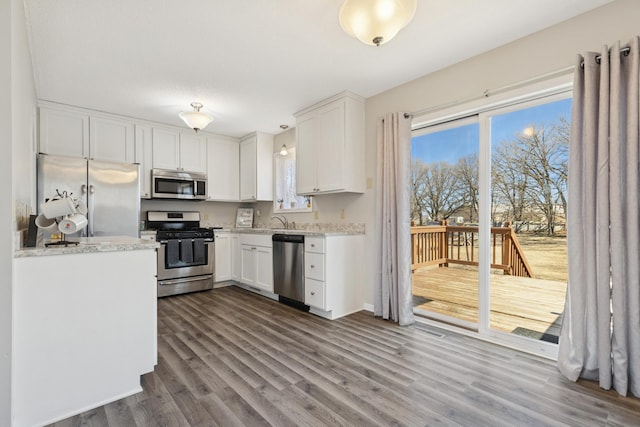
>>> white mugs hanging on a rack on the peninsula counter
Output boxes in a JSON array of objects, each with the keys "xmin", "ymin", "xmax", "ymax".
[{"xmin": 35, "ymin": 190, "xmax": 88, "ymax": 247}]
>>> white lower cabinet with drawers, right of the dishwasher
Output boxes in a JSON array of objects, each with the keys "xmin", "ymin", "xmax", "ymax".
[{"xmin": 304, "ymin": 235, "xmax": 364, "ymax": 319}]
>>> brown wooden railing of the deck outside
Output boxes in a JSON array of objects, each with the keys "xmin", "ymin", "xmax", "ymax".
[{"xmin": 411, "ymin": 225, "xmax": 534, "ymax": 277}]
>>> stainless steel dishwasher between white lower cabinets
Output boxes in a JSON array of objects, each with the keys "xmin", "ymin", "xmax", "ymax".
[{"xmin": 272, "ymin": 234, "xmax": 309, "ymax": 310}]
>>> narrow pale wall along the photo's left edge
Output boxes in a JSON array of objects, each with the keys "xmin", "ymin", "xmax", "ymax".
[{"xmin": 0, "ymin": 0, "xmax": 36, "ymax": 425}]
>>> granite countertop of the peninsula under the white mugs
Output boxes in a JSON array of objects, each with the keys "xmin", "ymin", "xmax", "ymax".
[{"xmin": 14, "ymin": 236, "xmax": 160, "ymax": 258}]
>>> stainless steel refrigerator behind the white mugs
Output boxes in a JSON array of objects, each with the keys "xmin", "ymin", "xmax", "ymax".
[{"xmin": 38, "ymin": 154, "xmax": 140, "ymax": 237}]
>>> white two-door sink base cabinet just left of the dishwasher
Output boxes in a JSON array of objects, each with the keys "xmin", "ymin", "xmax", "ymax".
[{"xmin": 239, "ymin": 234, "xmax": 273, "ymax": 292}]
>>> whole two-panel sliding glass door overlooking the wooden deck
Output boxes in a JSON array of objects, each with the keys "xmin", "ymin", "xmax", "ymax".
[{"xmin": 411, "ymin": 88, "xmax": 571, "ymax": 352}]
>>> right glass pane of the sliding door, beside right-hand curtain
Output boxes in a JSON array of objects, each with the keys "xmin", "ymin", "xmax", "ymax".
[{"xmin": 482, "ymin": 95, "xmax": 571, "ymax": 350}]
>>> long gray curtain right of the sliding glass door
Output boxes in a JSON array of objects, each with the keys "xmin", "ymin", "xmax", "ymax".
[{"xmin": 558, "ymin": 37, "xmax": 640, "ymax": 396}]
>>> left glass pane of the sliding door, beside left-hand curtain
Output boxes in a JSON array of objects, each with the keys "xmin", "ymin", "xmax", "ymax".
[{"xmin": 411, "ymin": 116, "xmax": 479, "ymax": 329}]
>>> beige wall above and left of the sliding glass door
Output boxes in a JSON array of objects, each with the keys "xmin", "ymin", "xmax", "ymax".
[{"xmin": 358, "ymin": 0, "xmax": 640, "ymax": 304}]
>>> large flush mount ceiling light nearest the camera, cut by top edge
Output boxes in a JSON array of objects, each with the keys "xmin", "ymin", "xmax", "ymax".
[{"xmin": 340, "ymin": 0, "xmax": 418, "ymax": 46}]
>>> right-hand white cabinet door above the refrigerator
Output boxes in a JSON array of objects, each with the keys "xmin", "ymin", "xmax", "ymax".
[{"xmin": 89, "ymin": 116, "xmax": 135, "ymax": 163}]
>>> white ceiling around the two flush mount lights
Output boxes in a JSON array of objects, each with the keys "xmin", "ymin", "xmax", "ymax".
[{"xmin": 25, "ymin": 0, "xmax": 610, "ymax": 137}]
